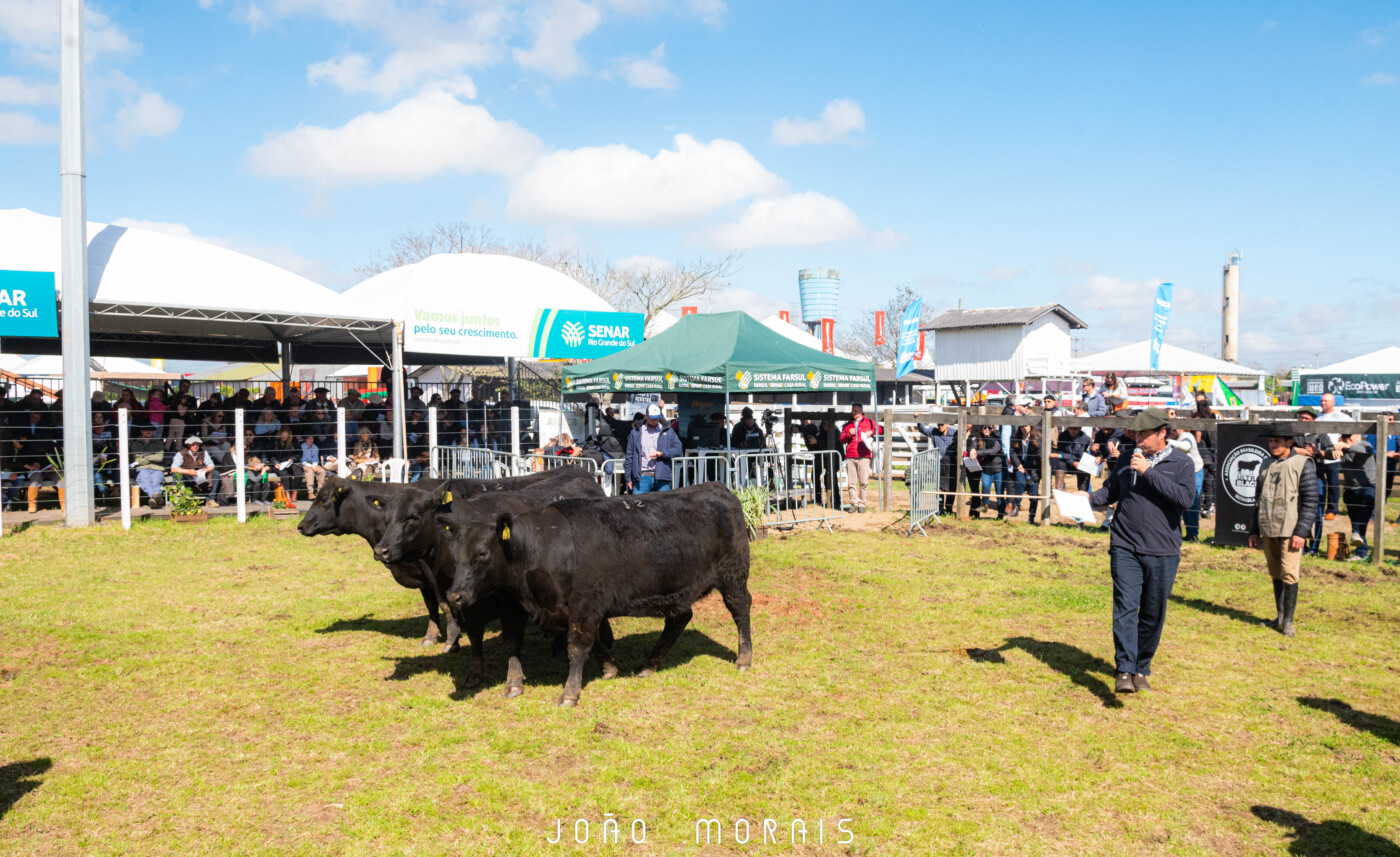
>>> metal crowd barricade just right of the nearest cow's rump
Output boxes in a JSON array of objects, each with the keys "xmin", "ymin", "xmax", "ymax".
[{"xmin": 729, "ymin": 450, "xmax": 844, "ymax": 529}]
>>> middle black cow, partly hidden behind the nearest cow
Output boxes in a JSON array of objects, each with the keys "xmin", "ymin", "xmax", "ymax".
[{"xmin": 374, "ymin": 468, "xmax": 617, "ymax": 697}]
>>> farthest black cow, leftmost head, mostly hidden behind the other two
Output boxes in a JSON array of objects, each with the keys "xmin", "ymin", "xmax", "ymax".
[{"xmin": 297, "ymin": 469, "xmax": 596, "ymax": 651}]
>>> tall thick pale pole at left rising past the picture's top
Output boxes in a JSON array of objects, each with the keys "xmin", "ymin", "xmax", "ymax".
[{"xmin": 59, "ymin": 0, "xmax": 92, "ymax": 527}]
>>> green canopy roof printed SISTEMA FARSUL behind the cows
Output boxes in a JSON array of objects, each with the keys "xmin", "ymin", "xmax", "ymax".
[{"xmin": 564, "ymin": 312, "xmax": 875, "ymax": 393}]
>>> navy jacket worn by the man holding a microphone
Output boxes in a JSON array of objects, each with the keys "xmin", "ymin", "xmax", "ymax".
[{"xmin": 1089, "ymin": 450, "xmax": 1196, "ymax": 556}]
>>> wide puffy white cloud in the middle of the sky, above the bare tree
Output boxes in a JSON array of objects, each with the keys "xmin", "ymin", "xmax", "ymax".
[{"xmin": 505, "ymin": 134, "xmax": 785, "ymax": 225}]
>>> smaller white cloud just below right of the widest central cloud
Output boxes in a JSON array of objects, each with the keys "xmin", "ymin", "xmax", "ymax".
[{"xmin": 704, "ymin": 192, "xmax": 865, "ymax": 251}]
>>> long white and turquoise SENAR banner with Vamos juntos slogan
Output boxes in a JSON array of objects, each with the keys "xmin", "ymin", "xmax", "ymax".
[{"xmin": 403, "ymin": 305, "xmax": 645, "ymax": 360}]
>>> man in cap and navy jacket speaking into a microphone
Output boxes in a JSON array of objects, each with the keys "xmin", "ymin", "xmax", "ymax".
[{"xmin": 1081, "ymin": 407, "xmax": 1196, "ymax": 693}]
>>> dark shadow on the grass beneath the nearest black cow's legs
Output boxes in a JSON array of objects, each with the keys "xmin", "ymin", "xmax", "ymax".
[{"xmin": 384, "ymin": 626, "xmax": 738, "ymax": 700}]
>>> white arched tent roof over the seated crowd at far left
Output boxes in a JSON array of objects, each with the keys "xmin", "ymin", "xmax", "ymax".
[{"xmin": 0, "ymin": 209, "xmax": 392, "ymax": 363}]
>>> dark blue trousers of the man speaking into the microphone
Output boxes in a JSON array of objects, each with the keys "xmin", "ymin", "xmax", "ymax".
[{"xmin": 1109, "ymin": 548, "xmax": 1182, "ymax": 675}]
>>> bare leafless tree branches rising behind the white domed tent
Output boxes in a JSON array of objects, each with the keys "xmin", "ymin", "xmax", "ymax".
[{"xmin": 356, "ymin": 221, "xmax": 741, "ymax": 322}]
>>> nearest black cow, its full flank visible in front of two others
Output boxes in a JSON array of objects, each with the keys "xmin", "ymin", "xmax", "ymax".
[{"xmin": 440, "ymin": 482, "xmax": 753, "ymax": 706}]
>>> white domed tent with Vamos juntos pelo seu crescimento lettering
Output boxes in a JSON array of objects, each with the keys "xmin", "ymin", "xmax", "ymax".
[{"xmin": 343, "ymin": 253, "xmax": 613, "ymax": 363}]
